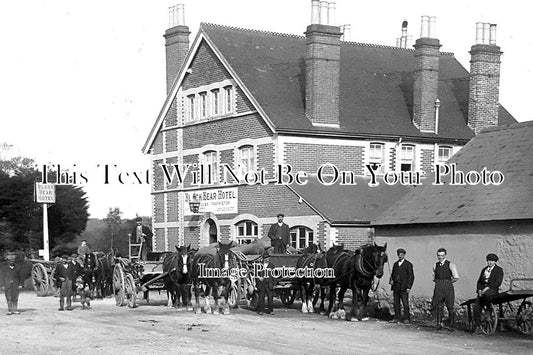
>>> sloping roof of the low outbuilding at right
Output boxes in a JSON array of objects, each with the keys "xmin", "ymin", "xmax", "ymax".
[{"xmin": 373, "ymin": 121, "xmax": 533, "ymax": 226}]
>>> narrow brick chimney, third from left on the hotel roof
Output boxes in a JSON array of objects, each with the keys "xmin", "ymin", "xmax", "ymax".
[{"xmin": 413, "ymin": 16, "xmax": 440, "ymax": 132}]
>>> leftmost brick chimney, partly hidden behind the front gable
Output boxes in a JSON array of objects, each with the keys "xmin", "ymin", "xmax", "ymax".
[{"xmin": 164, "ymin": 4, "xmax": 191, "ymax": 93}]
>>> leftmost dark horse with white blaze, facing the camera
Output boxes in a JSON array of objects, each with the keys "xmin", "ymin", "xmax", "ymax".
[{"xmin": 163, "ymin": 245, "xmax": 196, "ymax": 311}]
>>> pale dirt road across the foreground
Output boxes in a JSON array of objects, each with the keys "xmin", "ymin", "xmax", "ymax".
[{"xmin": 0, "ymin": 293, "xmax": 533, "ymax": 355}]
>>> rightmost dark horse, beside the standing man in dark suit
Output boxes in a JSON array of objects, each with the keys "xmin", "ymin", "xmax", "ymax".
[{"xmin": 328, "ymin": 243, "xmax": 388, "ymax": 320}]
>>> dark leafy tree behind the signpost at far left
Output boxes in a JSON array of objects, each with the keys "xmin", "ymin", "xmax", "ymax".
[{"xmin": 0, "ymin": 156, "xmax": 89, "ymax": 254}]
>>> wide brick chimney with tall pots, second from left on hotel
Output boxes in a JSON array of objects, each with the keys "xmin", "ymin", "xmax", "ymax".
[{"xmin": 305, "ymin": 0, "xmax": 342, "ymax": 127}]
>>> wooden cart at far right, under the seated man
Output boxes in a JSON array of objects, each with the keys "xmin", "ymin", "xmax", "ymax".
[{"xmin": 461, "ymin": 278, "xmax": 533, "ymax": 334}]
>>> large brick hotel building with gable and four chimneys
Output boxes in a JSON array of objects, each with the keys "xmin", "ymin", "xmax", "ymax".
[{"xmin": 143, "ymin": 0, "xmax": 515, "ymax": 251}]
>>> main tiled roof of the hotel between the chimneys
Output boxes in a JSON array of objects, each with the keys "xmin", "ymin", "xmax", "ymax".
[{"xmin": 201, "ymin": 23, "xmax": 516, "ymax": 140}]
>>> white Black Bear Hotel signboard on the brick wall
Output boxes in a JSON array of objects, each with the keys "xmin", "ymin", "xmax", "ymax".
[{"xmin": 185, "ymin": 187, "xmax": 239, "ymax": 216}]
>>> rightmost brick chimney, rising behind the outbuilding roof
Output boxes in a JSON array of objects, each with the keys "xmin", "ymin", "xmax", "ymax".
[{"xmin": 468, "ymin": 22, "xmax": 502, "ymax": 134}]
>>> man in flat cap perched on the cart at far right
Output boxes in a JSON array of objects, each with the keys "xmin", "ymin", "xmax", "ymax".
[{"xmin": 474, "ymin": 253, "xmax": 503, "ymax": 331}]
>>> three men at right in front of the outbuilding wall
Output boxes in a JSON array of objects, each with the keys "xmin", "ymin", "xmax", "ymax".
[{"xmin": 389, "ymin": 248, "xmax": 503, "ymax": 332}]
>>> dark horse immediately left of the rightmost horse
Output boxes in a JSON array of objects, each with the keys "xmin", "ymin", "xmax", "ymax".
[{"xmin": 296, "ymin": 245, "xmax": 351, "ymax": 314}]
